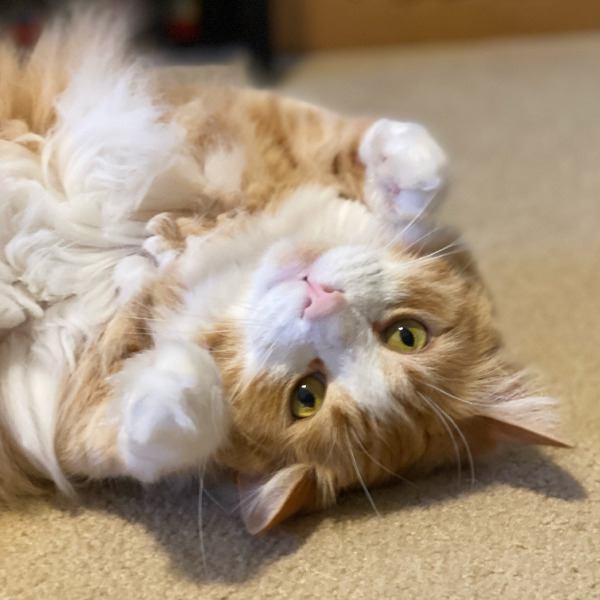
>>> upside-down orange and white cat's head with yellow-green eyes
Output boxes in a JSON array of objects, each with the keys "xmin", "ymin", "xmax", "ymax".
[{"xmin": 205, "ymin": 190, "xmax": 562, "ymax": 532}]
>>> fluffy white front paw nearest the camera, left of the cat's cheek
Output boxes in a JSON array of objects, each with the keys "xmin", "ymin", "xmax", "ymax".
[{"xmin": 114, "ymin": 341, "xmax": 228, "ymax": 482}]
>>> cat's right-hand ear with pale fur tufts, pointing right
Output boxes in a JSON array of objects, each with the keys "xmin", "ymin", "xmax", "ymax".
[{"xmin": 473, "ymin": 396, "xmax": 573, "ymax": 448}]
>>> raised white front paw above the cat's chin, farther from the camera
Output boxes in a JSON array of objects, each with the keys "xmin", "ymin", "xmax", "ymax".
[{"xmin": 359, "ymin": 119, "xmax": 447, "ymax": 221}]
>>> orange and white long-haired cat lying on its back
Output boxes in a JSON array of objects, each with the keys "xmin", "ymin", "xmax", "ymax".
[{"xmin": 0, "ymin": 18, "xmax": 567, "ymax": 533}]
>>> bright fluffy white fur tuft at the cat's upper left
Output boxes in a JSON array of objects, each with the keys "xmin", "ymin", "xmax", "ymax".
[{"xmin": 43, "ymin": 47, "xmax": 183, "ymax": 225}]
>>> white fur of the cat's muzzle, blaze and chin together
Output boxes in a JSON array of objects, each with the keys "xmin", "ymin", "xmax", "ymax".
[{"xmin": 244, "ymin": 188, "xmax": 402, "ymax": 418}]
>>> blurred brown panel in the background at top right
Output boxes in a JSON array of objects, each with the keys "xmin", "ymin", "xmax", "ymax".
[{"xmin": 269, "ymin": 0, "xmax": 600, "ymax": 52}]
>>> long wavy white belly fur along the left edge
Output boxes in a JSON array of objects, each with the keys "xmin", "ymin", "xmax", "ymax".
[{"xmin": 0, "ymin": 46, "xmax": 180, "ymax": 489}]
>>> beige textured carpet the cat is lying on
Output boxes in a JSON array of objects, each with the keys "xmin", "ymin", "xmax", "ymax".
[{"xmin": 0, "ymin": 35, "xmax": 600, "ymax": 600}]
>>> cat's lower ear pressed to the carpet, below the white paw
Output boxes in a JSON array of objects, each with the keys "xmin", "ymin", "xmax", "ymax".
[{"xmin": 237, "ymin": 464, "xmax": 317, "ymax": 534}]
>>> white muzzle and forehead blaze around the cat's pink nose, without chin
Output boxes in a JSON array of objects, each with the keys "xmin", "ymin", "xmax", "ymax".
[{"xmin": 244, "ymin": 191, "xmax": 406, "ymax": 418}]
